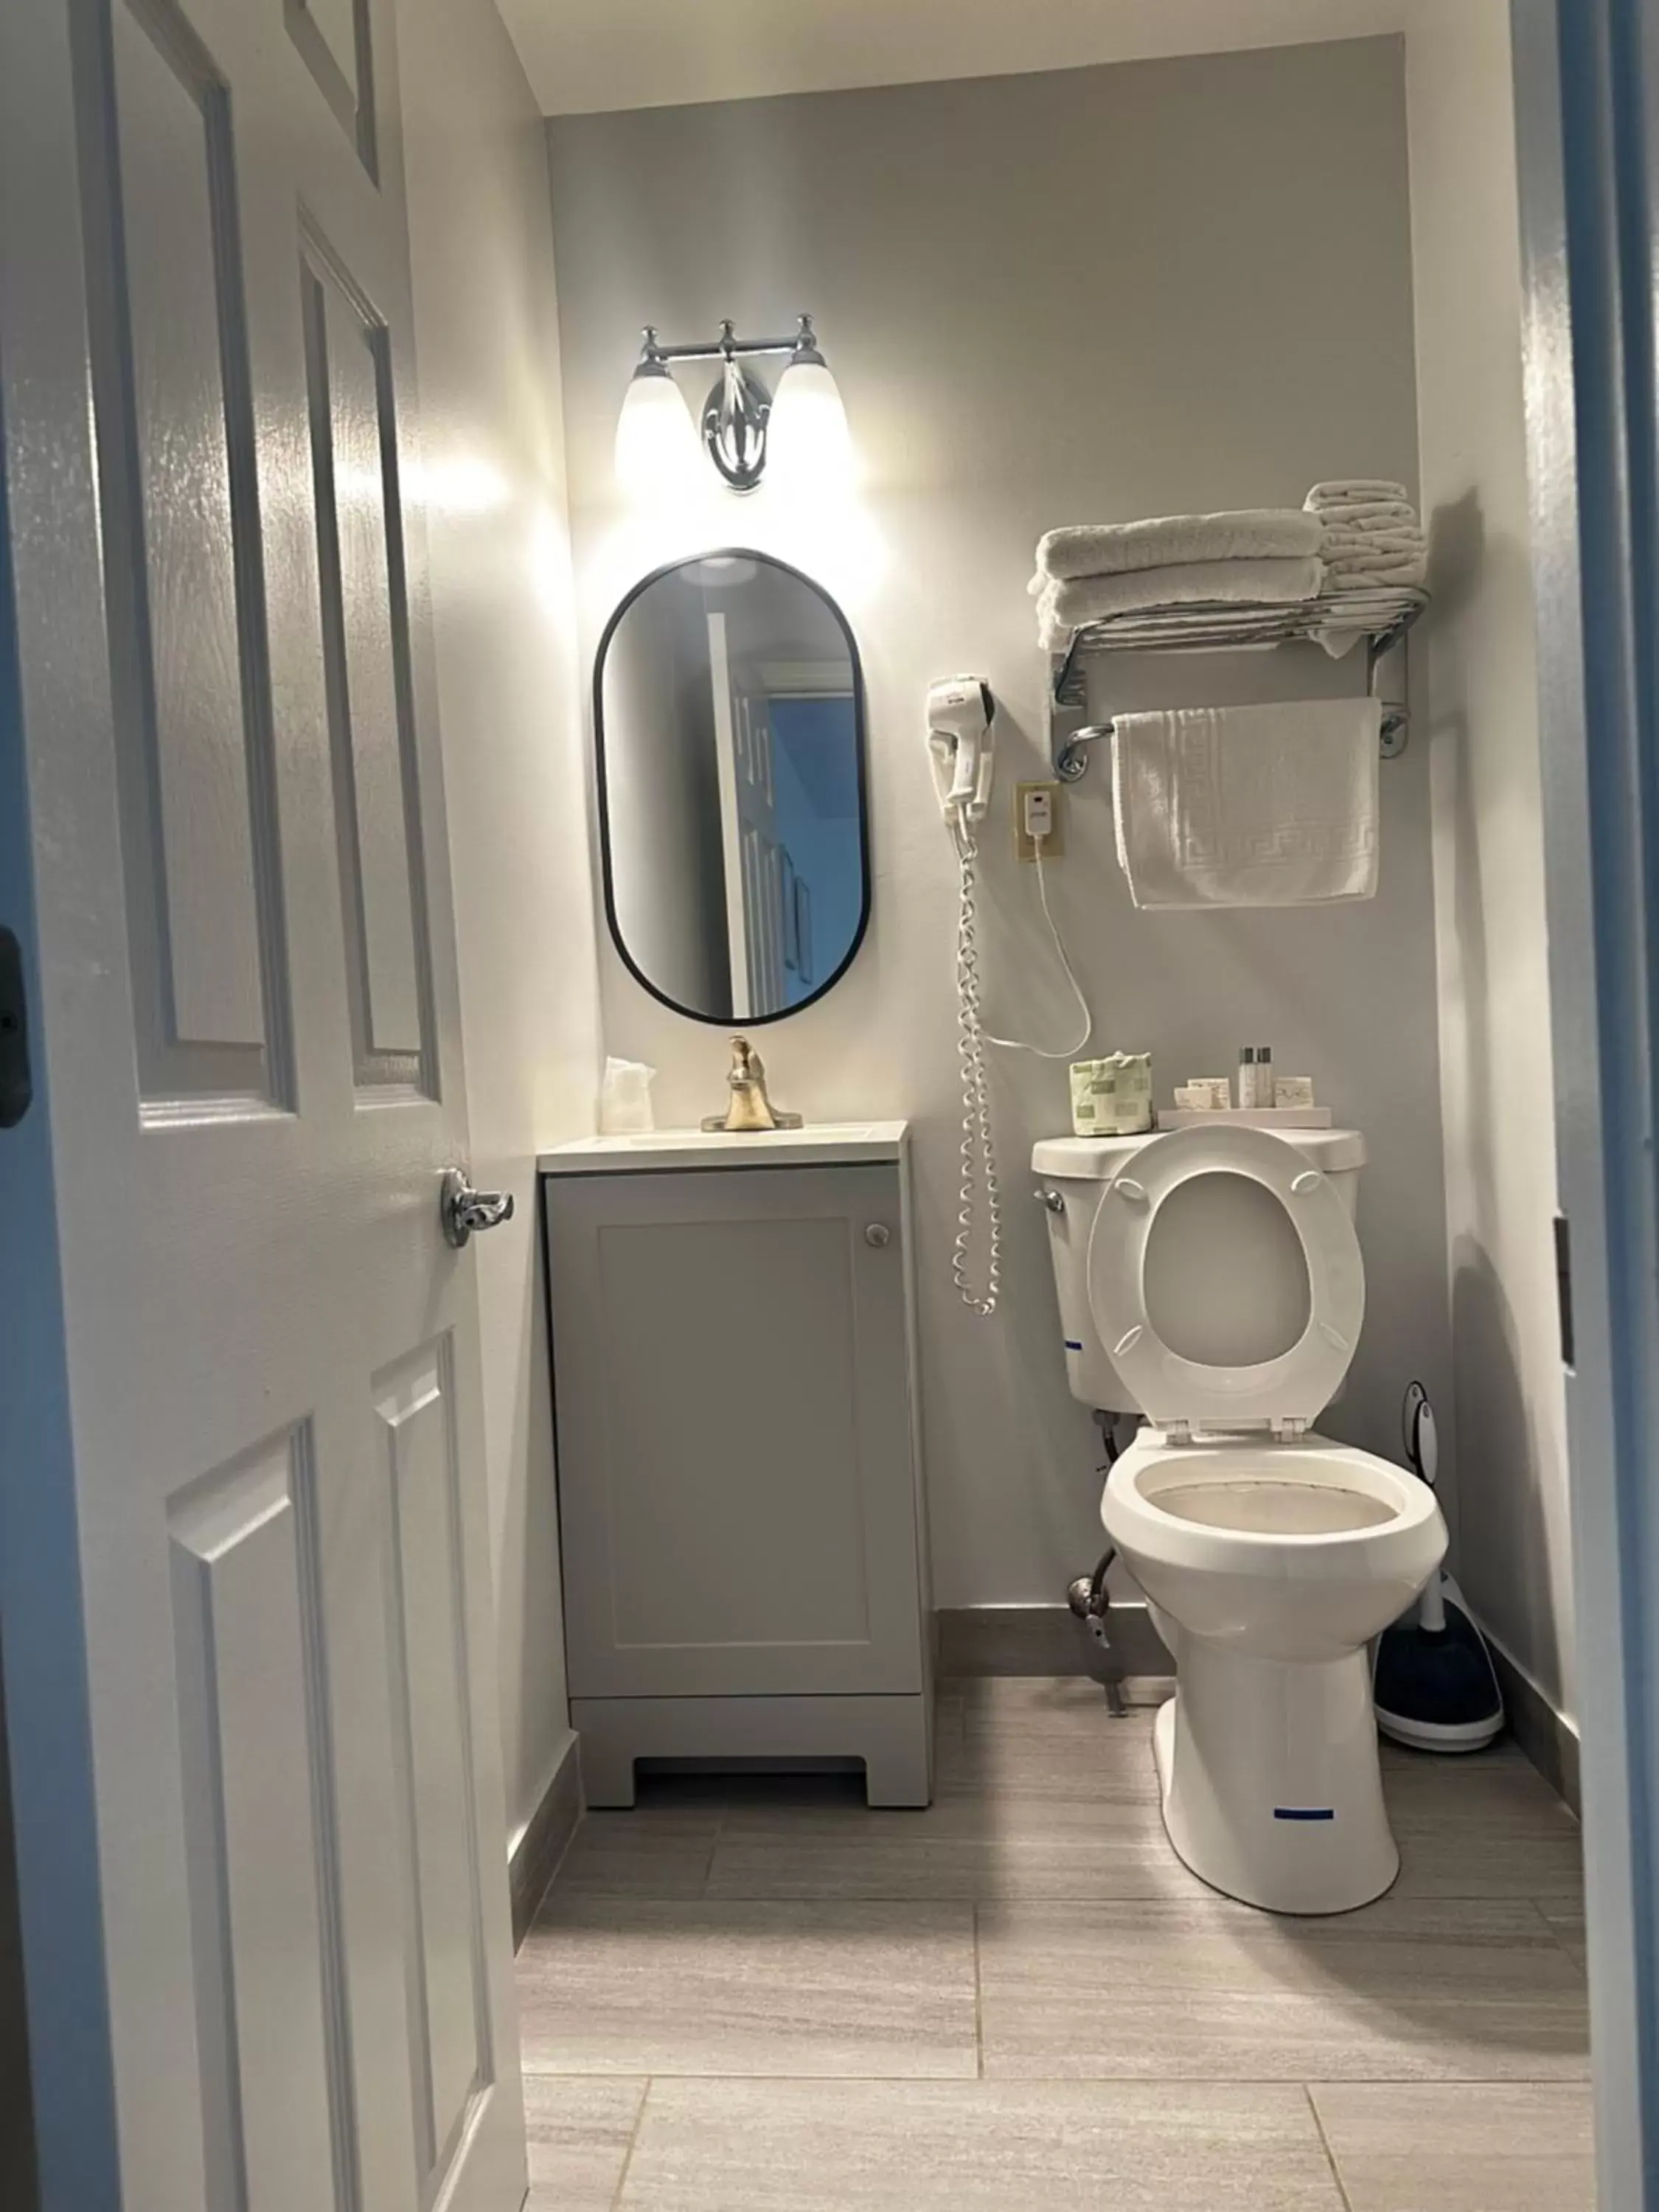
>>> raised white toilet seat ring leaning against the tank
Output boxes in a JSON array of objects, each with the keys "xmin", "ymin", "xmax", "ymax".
[{"xmin": 1088, "ymin": 1124, "xmax": 1365, "ymax": 1429}]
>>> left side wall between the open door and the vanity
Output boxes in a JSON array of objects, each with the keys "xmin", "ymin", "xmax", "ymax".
[{"xmin": 398, "ymin": 0, "xmax": 597, "ymax": 1832}]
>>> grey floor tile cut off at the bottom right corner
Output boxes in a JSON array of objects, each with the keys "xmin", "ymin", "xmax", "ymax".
[{"xmin": 1312, "ymin": 2081, "xmax": 1595, "ymax": 2212}]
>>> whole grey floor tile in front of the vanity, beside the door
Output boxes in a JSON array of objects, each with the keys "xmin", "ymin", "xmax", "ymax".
[{"xmin": 518, "ymin": 1891, "xmax": 982, "ymax": 2077}]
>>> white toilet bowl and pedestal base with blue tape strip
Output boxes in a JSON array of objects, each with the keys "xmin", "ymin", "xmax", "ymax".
[{"xmin": 1099, "ymin": 1429, "xmax": 1447, "ymax": 1913}]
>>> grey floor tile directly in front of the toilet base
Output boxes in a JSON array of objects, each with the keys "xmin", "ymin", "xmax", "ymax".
[{"xmin": 980, "ymin": 1898, "xmax": 1588, "ymax": 2081}]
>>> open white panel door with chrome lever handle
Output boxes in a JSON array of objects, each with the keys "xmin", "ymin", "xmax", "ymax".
[{"xmin": 0, "ymin": 0, "xmax": 524, "ymax": 2212}]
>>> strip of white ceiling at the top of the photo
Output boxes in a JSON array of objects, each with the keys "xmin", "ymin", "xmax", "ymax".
[{"xmin": 498, "ymin": 0, "xmax": 1416, "ymax": 115}]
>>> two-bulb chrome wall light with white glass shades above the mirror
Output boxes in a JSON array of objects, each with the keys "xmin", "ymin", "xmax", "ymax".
[{"xmin": 617, "ymin": 314, "xmax": 852, "ymax": 491}]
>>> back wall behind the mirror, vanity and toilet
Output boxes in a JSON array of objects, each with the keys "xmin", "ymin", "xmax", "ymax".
[{"xmin": 549, "ymin": 40, "xmax": 1449, "ymax": 1606}]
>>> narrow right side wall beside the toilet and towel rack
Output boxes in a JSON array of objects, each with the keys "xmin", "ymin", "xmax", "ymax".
[{"xmin": 1407, "ymin": 0, "xmax": 1575, "ymax": 1717}]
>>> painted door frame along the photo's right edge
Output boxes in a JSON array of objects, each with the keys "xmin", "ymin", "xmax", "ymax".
[{"xmin": 1511, "ymin": 0, "xmax": 1659, "ymax": 2212}]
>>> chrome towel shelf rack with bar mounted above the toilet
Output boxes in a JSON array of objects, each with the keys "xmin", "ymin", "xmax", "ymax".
[{"xmin": 1048, "ymin": 591, "xmax": 1429, "ymax": 783}]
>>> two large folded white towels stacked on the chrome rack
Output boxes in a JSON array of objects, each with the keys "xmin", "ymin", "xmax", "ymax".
[{"xmin": 1029, "ymin": 507, "xmax": 1325, "ymax": 653}]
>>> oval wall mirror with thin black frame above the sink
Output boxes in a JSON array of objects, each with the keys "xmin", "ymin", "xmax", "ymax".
[{"xmin": 593, "ymin": 551, "xmax": 869, "ymax": 1022}]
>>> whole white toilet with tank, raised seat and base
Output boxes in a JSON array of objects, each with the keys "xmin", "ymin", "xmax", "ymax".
[{"xmin": 1031, "ymin": 1124, "xmax": 1447, "ymax": 1913}]
